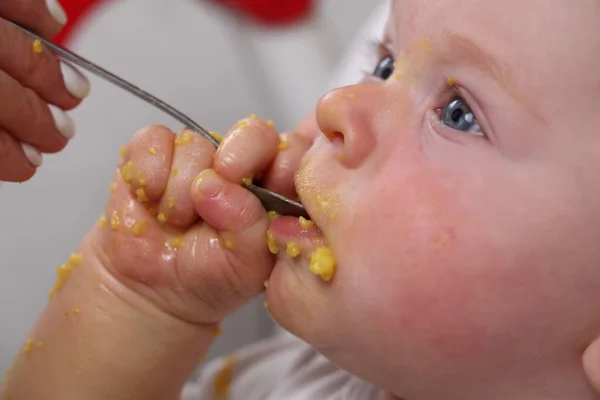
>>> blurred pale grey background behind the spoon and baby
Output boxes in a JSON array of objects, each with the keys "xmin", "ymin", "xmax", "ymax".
[{"xmin": 0, "ymin": 0, "xmax": 385, "ymax": 376}]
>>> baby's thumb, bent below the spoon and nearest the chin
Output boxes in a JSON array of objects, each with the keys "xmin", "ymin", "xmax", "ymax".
[{"xmin": 191, "ymin": 169, "xmax": 273, "ymax": 294}]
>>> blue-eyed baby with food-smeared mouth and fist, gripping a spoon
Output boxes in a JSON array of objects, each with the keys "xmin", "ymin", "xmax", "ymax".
[{"xmin": 5, "ymin": 0, "xmax": 600, "ymax": 400}]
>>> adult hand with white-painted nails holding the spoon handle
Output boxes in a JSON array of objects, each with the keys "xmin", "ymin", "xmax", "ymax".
[{"xmin": 0, "ymin": 0, "xmax": 90, "ymax": 182}]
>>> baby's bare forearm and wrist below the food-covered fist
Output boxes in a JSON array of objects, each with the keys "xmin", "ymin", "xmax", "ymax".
[{"xmin": 6, "ymin": 234, "xmax": 216, "ymax": 400}]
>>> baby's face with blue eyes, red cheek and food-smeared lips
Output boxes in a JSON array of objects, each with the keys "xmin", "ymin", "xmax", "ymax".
[{"xmin": 269, "ymin": 0, "xmax": 600, "ymax": 400}]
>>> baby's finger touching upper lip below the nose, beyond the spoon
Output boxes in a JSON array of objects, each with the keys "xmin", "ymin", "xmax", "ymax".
[{"xmin": 261, "ymin": 132, "xmax": 312, "ymax": 199}]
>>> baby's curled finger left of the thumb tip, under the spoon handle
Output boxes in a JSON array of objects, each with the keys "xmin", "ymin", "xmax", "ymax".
[{"xmin": 159, "ymin": 130, "xmax": 215, "ymax": 228}]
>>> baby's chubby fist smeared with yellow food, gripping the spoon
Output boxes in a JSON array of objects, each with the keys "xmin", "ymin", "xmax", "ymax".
[{"xmin": 91, "ymin": 118, "xmax": 280, "ymax": 324}]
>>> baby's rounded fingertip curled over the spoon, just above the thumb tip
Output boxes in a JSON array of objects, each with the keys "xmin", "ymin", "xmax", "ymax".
[{"xmin": 214, "ymin": 118, "xmax": 279, "ymax": 183}]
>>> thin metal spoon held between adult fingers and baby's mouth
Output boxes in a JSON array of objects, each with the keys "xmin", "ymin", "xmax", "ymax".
[{"xmin": 13, "ymin": 23, "xmax": 308, "ymax": 218}]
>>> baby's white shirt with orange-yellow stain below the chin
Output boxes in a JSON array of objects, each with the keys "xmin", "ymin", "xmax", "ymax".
[{"xmin": 181, "ymin": 333, "xmax": 381, "ymax": 400}]
